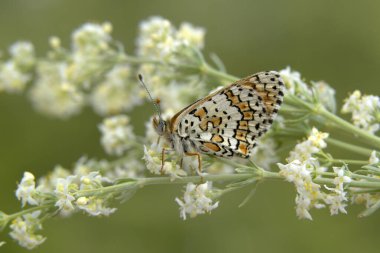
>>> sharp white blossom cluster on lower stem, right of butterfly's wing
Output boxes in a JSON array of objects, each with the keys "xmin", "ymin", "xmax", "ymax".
[{"xmin": 278, "ymin": 128, "xmax": 351, "ymax": 220}]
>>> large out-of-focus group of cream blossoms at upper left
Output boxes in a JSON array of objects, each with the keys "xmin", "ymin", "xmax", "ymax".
[{"xmin": 0, "ymin": 22, "xmax": 145, "ymax": 119}]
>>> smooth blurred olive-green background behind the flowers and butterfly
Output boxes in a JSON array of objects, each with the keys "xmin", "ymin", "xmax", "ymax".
[{"xmin": 0, "ymin": 0, "xmax": 380, "ymax": 253}]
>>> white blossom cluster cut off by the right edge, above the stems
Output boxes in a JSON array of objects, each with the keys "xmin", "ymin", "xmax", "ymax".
[{"xmin": 342, "ymin": 90, "xmax": 380, "ymax": 133}]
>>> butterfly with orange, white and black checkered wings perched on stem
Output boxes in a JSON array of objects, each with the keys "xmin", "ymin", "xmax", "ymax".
[{"xmin": 139, "ymin": 71, "xmax": 285, "ymax": 171}]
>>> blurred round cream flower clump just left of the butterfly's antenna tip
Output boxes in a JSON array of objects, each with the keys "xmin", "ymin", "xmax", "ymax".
[{"xmin": 91, "ymin": 65, "xmax": 145, "ymax": 115}]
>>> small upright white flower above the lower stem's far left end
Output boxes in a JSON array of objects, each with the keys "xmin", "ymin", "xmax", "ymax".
[{"xmin": 16, "ymin": 172, "xmax": 38, "ymax": 206}]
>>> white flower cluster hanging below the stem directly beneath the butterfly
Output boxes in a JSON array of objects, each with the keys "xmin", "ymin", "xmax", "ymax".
[{"xmin": 175, "ymin": 182, "xmax": 219, "ymax": 220}]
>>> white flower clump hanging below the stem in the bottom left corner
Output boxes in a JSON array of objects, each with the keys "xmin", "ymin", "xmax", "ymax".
[{"xmin": 9, "ymin": 211, "xmax": 46, "ymax": 249}]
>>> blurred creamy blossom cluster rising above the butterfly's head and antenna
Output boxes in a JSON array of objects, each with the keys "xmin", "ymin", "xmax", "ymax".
[{"xmin": 137, "ymin": 17, "xmax": 207, "ymax": 115}]
